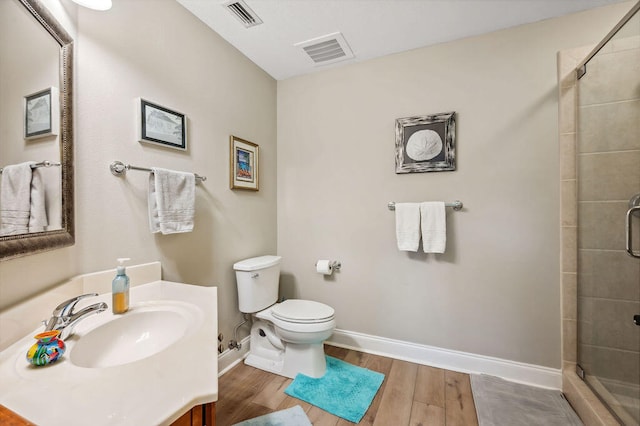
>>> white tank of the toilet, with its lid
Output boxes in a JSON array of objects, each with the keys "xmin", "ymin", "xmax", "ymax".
[{"xmin": 233, "ymin": 256, "xmax": 282, "ymax": 313}]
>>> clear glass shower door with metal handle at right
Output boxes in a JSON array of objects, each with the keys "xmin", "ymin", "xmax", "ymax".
[{"xmin": 577, "ymin": 5, "xmax": 640, "ymax": 425}]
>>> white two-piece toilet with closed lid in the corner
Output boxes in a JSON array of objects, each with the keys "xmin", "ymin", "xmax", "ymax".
[{"xmin": 233, "ymin": 256, "xmax": 336, "ymax": 378}]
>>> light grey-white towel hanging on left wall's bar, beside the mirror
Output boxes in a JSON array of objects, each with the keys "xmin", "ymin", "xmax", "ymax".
[{"xmin": 149, "ymin": 167, "xmax": 196, "ymax": 235}]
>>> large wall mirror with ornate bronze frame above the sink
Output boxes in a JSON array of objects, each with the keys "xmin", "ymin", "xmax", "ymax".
[{"xmin": 0, "ymin": 0, "xmax": 74, "ymax": 260}]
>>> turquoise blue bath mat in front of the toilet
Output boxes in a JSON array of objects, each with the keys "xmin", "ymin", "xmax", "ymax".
[{"xmin": 284, "ymin": 356, "xmax": 384, "ymax": 423}]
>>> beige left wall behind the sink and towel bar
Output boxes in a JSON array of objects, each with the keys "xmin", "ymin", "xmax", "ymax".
[{"xmin": 0, "ymin": 0, "xmax": 276, "ymax": 350}]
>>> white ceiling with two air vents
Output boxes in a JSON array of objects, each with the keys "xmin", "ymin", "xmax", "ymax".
[{"xmin": 177, "ymin": 0, "xmax": 622, "ymax": 80}]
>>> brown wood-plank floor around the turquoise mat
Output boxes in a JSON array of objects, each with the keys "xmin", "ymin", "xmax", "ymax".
[{"xmin": 216, "ymin": 345, "xmax": 478, "ymax": 426}]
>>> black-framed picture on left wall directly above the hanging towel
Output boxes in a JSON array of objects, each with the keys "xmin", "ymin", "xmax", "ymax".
[{"xmin": 136, "ymin": 98, "xmax": 187, "ymax": 151}]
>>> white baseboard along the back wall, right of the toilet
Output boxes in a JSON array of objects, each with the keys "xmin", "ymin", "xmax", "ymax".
[{"xmin": 325, "ymin": 329, "xmax": 562, "ymax": 389}]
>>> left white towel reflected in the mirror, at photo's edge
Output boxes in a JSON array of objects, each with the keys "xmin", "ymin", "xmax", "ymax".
[{"xmin": 0, "ymin": 161, "xmax": 34, "ymax": 235}]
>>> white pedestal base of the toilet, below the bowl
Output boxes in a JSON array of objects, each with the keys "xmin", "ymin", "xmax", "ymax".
[{"xmin": 244, "ymin": 320, "xmax": 327, "ymax": 379}]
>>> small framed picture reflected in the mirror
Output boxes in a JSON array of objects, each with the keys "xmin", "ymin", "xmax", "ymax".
[{"xmin": 24, "ymin": 87, "xmax": 60, "ymax": 139}]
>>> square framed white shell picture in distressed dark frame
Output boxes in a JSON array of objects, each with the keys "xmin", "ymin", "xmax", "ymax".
[{"xmin": 396, "ymin": 112, "xmax": 456, "ymax": 173}]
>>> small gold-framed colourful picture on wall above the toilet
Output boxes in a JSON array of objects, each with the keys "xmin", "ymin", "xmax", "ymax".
[{"xmin": 229, "ymin": 135, "xmax": 259, "ymax": 191}]
